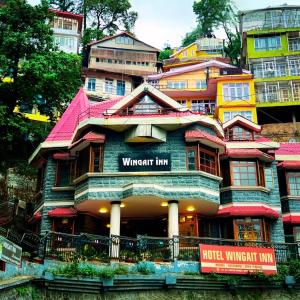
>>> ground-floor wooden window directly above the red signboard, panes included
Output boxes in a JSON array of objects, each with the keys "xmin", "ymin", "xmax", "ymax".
[{"xmin": 234, "ymin": 218, "xmax": 270, "ymax": 241}]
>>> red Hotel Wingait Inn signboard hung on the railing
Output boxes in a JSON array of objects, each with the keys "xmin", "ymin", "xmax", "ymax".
[{"xmin": 200, "ymin": 244, "xmax": 277, "ymax": 275}]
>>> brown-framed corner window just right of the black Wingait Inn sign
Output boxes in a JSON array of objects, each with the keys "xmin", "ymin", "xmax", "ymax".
[{"xmin": 187, "ymin": 144, "xmax": 218, "ymax": 175}]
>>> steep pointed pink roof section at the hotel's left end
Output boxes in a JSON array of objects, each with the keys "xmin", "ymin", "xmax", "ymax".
[{"xmin": 46, "ymin": 88, "xmax": 89, "ymax": 142}]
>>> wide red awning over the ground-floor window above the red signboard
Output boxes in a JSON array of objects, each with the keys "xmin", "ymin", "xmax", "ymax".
[{"xmin": 217, "ymin": 203, "xmax": 280, "ymax": 219}]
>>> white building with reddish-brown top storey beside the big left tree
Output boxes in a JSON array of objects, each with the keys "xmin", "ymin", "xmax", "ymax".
[{"xmin": 51, "ymin": 10, "xmax": 83, "ymax": 54}]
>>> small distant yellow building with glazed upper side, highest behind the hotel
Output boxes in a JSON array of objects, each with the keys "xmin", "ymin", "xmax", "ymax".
[{"xmin": 163, "ymin": 38, "xmax": 229, "ymax": 72}]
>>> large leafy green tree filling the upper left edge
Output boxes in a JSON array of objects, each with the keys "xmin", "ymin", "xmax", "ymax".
[{"xmin": 0, "ymin": 0, "xmax": 81, "ymax": 161}]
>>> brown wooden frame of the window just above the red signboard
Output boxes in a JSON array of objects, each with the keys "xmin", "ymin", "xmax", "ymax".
[{"xmin": 233, "ymin": 217, "xmax": 270, "ymax": 242}]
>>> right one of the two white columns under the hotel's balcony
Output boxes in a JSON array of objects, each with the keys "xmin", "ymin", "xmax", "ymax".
[{"xmin": 168, "ymin": 200, "xmax": 179, "ymax": 259}]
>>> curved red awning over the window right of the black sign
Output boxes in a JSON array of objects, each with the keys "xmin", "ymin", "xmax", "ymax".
[{"xmin": 185, "ymin": 130, "xmax": 226, "ymax": 153}]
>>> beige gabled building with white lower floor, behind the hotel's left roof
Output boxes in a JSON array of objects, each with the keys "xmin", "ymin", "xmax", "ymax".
[{"xmin": 83, "ymin": 32, "xmax": 159, "ymax": 100}]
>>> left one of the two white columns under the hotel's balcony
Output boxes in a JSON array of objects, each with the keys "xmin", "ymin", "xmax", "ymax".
[{"xmin": 109, "ymin": 201, "xmax": 121, "ymax": 259}]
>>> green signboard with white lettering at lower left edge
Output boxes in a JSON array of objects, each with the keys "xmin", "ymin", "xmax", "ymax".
[{"xmin": 0, "ymin": 237, "xmax": 22, "ymax": 266}]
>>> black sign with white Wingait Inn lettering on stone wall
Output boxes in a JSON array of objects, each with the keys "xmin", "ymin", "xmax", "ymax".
[{"xmin": 119, "ymin": 152, "xmax": 171, "ymax": 172}]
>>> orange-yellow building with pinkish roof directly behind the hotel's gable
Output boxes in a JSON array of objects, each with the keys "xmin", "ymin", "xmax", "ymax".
[{"xmin": 148, "ymin": 60, "xmax": 257, "ymax": 123}]
